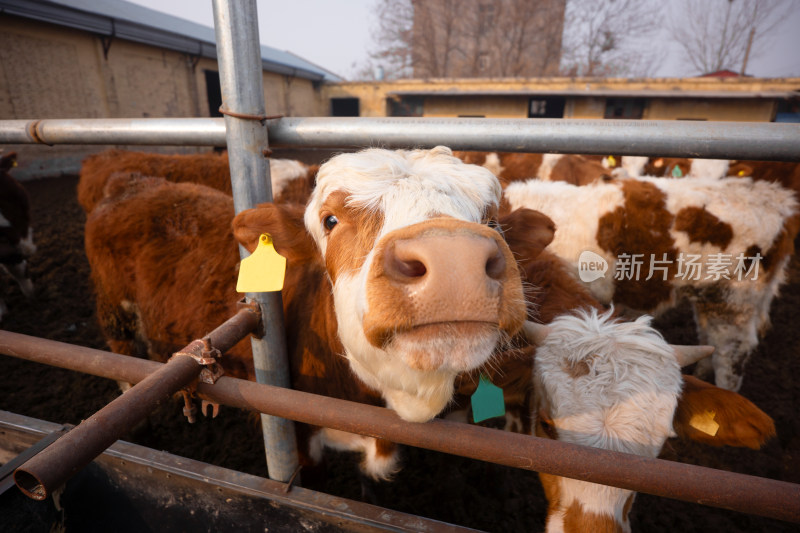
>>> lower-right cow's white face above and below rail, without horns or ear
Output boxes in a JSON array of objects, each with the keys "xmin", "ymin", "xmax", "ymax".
[{"xmin": 534, "ymin": 309, "xmax": 710, "ymax": 532}]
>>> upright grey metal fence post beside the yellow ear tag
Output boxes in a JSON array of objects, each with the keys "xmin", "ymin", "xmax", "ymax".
[{"xmin": 213, "ymin": 0, "xmax": 298, "ymax": 482}]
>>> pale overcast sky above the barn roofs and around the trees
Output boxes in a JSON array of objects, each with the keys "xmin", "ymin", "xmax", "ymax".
[{"xmin": 129, "ymin": 0, "xmax": 800, "ymax": 78}]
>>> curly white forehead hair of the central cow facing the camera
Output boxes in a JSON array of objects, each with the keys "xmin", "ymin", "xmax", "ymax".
[{"xmin": 305, "ymin": 146, "xmax": 502, "ymax": 253}]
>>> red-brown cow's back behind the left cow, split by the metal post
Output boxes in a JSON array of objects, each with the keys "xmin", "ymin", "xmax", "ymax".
[{"xmin": 78, "ymin": 149, "xmax": 319, "ymax": 213}]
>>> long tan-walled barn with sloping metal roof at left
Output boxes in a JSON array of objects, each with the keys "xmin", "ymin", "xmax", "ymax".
[{"xmin": 0, "ymin": 0, "xmax": 339, "ymax": 178}]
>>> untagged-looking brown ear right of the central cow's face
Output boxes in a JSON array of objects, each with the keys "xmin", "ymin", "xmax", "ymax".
[{"xmin": 499, "ymin": 208, "xmax": 556, "ymax": 266}]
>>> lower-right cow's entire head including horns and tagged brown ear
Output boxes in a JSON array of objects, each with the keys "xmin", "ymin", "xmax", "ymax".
[{"xmin": 525, "ymin": 309, "xmax": 775, "ymax": 533}]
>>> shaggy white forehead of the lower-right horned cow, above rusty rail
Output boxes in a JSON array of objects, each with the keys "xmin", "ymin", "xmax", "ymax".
[{"xmin": 535, "ymin": 309, "xmax": 683, "ymax": 457}]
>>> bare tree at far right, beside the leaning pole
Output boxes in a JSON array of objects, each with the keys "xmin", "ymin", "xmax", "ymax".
[{"xmin": 669, "ymin": 0, "xmax": 792, "ymax": 74}]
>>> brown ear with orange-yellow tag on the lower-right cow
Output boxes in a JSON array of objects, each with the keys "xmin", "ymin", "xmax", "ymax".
[{"xmin": 672, "ymin": 375, "xmax": 775, "ymax": 450}]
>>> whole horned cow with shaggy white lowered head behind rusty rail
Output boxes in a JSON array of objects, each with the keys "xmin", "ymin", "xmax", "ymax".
[{"xmin": 456, "ymin": 249, "xmax": 775, "ymax": 533}]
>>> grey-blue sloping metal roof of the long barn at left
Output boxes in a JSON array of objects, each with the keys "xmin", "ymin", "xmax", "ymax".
[{"xmin": 0, "ymin": 0, "xmax": 340, "ymax": 81}]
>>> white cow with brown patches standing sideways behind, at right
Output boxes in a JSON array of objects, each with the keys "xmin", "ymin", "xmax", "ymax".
[{"xmin": 504, "ymin": 178, "xmax": 800, "ymax": 390}]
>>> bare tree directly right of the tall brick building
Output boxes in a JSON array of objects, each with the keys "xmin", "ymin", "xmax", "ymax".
[{"xmin": 561, "ymin": 0, "xmax": 665, "ymax": 77}]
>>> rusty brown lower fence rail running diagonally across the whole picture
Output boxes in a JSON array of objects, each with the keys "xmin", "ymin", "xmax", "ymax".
[{"xmin": 0, "ymin": 331, "xmax": 800, "ymax": 522}]
